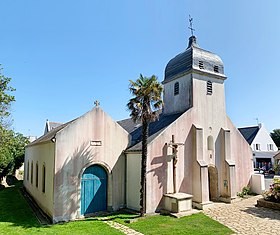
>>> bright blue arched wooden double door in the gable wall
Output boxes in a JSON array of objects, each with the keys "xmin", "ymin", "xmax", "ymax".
[{"xmin": 81, "ymin": 165, "xmax": 107, "ymax": 215}]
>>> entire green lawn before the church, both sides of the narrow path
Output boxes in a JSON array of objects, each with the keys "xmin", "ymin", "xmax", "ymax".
[{"xmin": 0, "ymin": 182, "xmax": 233, "ymax": 235}]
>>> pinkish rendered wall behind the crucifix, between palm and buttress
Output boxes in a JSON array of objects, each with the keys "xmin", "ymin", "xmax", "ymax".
[{"xmin": 144, "ymin": 109, "xmax": 193, "ymax": 213}]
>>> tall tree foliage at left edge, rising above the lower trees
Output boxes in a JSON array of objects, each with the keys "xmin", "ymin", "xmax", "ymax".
[{"xmin": 0, "ymin": 64, "xmax": 15, "ymax": 125}]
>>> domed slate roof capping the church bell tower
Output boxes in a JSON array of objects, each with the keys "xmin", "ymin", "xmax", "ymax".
[{"xmin": 163, "ymin": 36, "xmax": 226, "ymax": 83}]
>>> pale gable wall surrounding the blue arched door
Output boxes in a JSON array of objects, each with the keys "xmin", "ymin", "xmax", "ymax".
[{"xmin": 54, "ymin": 108, "xmax": 129, "ymax": 222}]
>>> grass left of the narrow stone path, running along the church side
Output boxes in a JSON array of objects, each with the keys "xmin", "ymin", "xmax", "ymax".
[{"xmin": 0, "ymin": 182, "xmax": 123, "ymax": 235}]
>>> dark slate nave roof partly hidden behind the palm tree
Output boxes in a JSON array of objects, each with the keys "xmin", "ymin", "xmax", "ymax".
[{"xmin": 118, "ymin": 113, "xmax": 182, "ymax": 151}]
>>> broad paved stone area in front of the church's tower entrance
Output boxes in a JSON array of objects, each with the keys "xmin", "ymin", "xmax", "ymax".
[{"xmin": 204, "ymin": 196, "xmax": 280, "ymax": 235}]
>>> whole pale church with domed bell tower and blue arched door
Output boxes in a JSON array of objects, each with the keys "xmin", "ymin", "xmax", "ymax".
[{"xmin": 24, "ymin": 36, "xmax": 253, "ymax": 223}]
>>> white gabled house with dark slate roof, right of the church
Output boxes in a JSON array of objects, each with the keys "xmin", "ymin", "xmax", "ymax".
[{"xmin": 238, "ymin": 123, "xmax": 278, "ymax": 170}]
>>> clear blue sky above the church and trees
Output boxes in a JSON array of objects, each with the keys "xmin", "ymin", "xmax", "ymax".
[{"xmin": 0, "ymin": 0, "xmax": 280, "ymax": 137}]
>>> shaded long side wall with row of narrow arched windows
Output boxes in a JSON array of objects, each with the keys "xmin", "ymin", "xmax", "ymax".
[{"xmin": 24, "ymin": 142, "xmax": 55, "ymax": 217}]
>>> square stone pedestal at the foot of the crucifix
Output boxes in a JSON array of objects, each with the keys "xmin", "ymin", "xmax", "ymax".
[{"xmin": 163, "ymin": 193, "xmax": 193, "ymax": 213}]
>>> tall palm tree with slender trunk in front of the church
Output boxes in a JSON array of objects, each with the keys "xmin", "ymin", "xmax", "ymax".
[{"xmin": 127, "ymin": 74, "xmax": 163, "ymax": 216}]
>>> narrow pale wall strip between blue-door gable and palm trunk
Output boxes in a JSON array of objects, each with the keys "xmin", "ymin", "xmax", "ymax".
[{"xmin": 126, "ymin": 153, "xmax": 141, "ymax": 210}]
